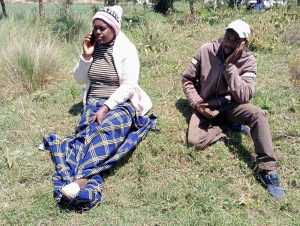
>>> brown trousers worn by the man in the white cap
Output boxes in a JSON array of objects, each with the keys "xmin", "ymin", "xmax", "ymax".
[{"xmin": 188, "ymin": 102, "xmax": 276, "ymax": 170}]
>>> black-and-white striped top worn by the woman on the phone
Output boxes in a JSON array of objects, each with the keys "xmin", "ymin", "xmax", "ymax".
[{"xmin": 88, "ymin": 41, "xmax": 120, "ymax": 99}]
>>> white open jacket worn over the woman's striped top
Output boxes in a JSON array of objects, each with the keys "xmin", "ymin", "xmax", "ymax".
[{"xmin": 73, "ymin": 31, "xmax": 152, "ymax": 115}]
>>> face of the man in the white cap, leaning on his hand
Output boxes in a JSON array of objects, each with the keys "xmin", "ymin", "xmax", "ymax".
[{"xmin": 223, "ymin": 29, "xmax": 244, "ymax": 55}]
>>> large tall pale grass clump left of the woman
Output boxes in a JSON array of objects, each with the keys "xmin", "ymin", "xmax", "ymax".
[{"xmin": 0, "ymin": 16, "xmax": 66, "ymax": 95}]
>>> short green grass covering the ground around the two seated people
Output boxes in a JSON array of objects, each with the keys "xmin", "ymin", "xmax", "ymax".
[{"xmin": 0, "ymin": 0, "xmax": 300, "ymax": 225}]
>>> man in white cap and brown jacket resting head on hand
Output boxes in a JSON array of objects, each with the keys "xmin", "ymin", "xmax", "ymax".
[{"xmin": 182, "ymin": 20, "xmax": 284, "ymax": 198}]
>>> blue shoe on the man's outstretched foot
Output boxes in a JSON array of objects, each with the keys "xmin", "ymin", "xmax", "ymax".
[{"xmin": 259, "ymin": 170, "xmax": 284, "ymax": 199}]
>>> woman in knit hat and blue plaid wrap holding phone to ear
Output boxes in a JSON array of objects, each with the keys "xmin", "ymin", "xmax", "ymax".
[{"xmin": 41, "ymin": 5, "xmax": 156, "ymax": 208}]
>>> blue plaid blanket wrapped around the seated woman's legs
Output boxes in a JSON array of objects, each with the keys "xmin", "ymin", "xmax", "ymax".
[{"xmin": 43, "ymin": 100, "xmax": 156, "ymax": 210}]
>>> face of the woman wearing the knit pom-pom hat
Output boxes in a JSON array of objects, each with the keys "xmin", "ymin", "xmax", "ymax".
[{"xmin": 93, "ymin": 19, "xmax": 115, "ymax": 44}]
